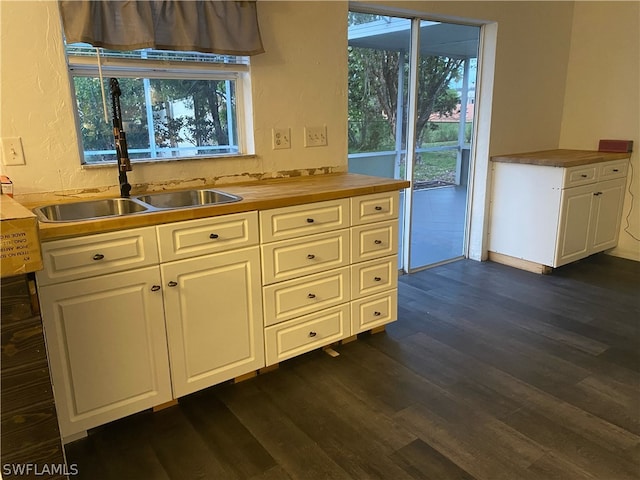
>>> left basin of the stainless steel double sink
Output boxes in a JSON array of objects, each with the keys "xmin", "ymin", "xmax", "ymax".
[{"xmin": 33, "ymin": 198, "xmax": 149, "ymax": 222}]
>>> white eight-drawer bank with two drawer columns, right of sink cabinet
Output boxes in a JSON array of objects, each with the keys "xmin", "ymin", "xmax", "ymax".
[{"xmin": 260, "ymin": 192, "xmax": 399, "ymax": 365}]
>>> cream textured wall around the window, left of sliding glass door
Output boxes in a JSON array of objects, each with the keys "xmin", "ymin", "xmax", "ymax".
[{"xmin": 0, "ymin": 1, "xmax": 348, "ymax": 194}]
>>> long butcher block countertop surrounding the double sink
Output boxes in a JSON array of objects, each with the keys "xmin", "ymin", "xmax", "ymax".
[{"xmin": 23, "ymin": 173, "xmax": 410, "ymax": 241}]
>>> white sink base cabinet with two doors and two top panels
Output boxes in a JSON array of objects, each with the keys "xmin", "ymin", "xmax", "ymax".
[{"xmin": 37, "ymin": 212, "xmax": 264, "ymax": 440}]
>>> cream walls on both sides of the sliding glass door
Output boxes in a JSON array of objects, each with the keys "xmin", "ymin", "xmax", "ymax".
[{"xmin": 0, "ymin": 0, "xmax": 640, "ymax": 258}]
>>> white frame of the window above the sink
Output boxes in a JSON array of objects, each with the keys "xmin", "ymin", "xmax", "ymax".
[{"xmin": 65, "ymin": 44, "xmax": 255, "ymax": 167}]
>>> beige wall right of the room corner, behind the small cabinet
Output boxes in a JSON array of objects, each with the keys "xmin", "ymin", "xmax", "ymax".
[{"xmin": 560, "ymin": 2, "xmax": 640, "ymax": 260}]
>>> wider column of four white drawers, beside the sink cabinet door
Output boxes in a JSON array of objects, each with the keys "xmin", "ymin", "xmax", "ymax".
[{"xmin": 260, "ymin": 199, "xmax": 351, "ymax": 365}]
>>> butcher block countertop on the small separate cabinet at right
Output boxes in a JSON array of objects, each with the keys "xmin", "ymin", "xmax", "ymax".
[{"xmin": 491, "ymin": 149, "xmax": 631, "ymax": 168}]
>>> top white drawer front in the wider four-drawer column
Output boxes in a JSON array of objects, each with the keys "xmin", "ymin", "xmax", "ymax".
[{"xmin": 260, "ymin": 198, "xmax": 349, "ymax": 243}]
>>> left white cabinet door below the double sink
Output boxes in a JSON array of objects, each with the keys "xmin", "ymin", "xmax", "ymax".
[{"xmin": 39, "ymin": 266, "xmax": 172, "ymax": 438}]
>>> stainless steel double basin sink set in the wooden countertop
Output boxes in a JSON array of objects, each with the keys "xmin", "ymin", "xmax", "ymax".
[{"xmin": 33, "ymin": 189, "xmax": 242, "ymax": 222}]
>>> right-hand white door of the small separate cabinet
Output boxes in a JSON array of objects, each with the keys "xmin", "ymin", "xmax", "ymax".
[{"xmin": 590, "ymin": 178, "xmax": 626, "ymax": 253}]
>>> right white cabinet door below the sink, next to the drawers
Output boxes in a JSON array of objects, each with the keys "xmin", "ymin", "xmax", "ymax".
[{"xmin": 160, "ymin": 247, "xmax": 264, "ymax": 398}]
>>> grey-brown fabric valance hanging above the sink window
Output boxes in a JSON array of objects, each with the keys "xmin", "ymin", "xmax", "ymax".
[{"xmin": 59, "ymin": 0, "xmax": 264, "ymax": 55}]
